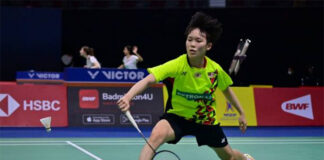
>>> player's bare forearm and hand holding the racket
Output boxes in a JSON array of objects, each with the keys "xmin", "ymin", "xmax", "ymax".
[{"xmin": 117, "ymin": 74, "xmax": 156, "ymax": 112}]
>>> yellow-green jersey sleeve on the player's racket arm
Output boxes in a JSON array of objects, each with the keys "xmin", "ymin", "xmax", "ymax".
[{"xmin": 147, "ymin": 58, "xmax": 181, "ymax": 82}]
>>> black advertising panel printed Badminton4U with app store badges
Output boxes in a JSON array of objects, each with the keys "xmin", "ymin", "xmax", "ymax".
[{"xmin": 68, "ymin": 87, "xmax": 163, "ymax": 127}]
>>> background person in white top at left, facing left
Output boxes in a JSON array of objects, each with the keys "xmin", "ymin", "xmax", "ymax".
[{"xmin": 80, "ymin": 46, "xmax": 101, "ymax": 68}]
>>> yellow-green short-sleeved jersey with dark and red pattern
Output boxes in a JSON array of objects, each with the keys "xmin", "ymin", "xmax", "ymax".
[{"xmin": 148, "ymin": 54, "xmax": 233, "ymax": 125}]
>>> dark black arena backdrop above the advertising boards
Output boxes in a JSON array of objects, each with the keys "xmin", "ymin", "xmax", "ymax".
[{"xmin": 0, "ymin": 0, "xmax": 323, "ymax": 86}]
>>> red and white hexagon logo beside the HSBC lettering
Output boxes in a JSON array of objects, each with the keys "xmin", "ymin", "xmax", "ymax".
[{"xmin": 0, "ymin": 94, "xmax": 20, "ymax": 117}]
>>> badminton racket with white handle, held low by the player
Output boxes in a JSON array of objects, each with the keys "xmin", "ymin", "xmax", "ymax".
[{"xmin": 125, "ymin": 111, "xmax": 180, "ymax": 160}]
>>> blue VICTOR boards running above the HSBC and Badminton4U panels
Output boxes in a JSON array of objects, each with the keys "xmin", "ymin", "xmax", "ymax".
[{"xmin": 16, "ymin": 67, "xmax": 148, "ymax": 84}]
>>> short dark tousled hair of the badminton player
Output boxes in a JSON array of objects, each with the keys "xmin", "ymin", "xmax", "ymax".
[{"xmin": 185, "ymin": 12, "xmax": 223, "ymax": 44}]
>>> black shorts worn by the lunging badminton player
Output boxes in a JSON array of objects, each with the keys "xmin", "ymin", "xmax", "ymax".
[{"xmin": 161, "ymin": 113, "xmax": 228, "ymax": 148}]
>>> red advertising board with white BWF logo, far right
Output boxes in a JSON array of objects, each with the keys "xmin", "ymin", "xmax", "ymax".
[{"xmin": 254, "ymin": 87, "xmax": 324, "ymax": 126}]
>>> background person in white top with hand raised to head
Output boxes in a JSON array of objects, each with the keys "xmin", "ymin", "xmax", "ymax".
[{"xmin": 118, "ymin": 45, "xmax": 143, "ymax": 69}]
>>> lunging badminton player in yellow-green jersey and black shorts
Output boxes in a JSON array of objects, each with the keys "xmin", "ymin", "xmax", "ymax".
[{"xmin": 117, "ymin": 12, "xmax": 253, "ymax": 160}]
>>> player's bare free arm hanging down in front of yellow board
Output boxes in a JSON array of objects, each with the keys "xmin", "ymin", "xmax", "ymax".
[{"xmin": 223, "ymin": 87, "xmax": 247, "ymax": 133}]
